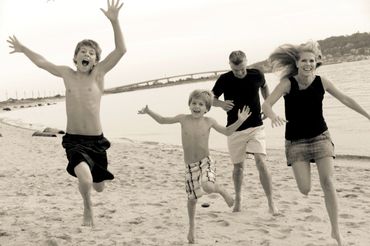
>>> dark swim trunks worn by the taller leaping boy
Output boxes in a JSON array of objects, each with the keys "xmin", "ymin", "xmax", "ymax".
[{"xmin": 62, "ymin": 133, "xmax": 114, "ymax": 183}]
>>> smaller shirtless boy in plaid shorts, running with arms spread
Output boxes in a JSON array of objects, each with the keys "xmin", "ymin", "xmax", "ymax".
[{"xmin": 139, "ymin": 90, "xmax": 251, "ymax": 243}]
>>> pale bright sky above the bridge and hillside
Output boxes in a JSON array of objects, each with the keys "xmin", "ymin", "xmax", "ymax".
[{"xmin": 0, "ymin": 0, "xmax": 370, "ymax": 101}]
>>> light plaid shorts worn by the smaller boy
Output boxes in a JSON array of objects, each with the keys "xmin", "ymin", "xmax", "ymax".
[{"xmin": 185, "ymin": 157, "xmax": 216, "ymax": 199}]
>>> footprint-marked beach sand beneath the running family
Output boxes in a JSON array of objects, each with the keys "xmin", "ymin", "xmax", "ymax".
[{"xmin": 0, "ymin": 123, "xmax": 370, "ymax": 246}]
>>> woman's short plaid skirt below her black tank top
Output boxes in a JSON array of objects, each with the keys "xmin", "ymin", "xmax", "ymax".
[{"xmin": 285, "ymin": 131, "xmax": 335, "ymax": 166}]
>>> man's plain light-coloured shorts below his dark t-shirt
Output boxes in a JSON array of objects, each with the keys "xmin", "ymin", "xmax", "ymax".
[{"xmin": 227, "ymin": 125, "xmax": 266, "ymax": 164}]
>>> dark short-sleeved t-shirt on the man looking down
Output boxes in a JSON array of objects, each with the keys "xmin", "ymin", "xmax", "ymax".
[{"xmin": 212, "ymin": 69, "xmax": 266, "ymax": 131}]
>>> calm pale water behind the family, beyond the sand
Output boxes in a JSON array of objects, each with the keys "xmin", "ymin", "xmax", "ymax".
[{"xmin": 0, "ymin": 60, "xmax": 370, "ymax": 156}]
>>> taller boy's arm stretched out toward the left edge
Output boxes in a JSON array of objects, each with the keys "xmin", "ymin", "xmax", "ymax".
[{"xmin": 7, "ymin": 36, "xmax": 69, "ymax": 77}]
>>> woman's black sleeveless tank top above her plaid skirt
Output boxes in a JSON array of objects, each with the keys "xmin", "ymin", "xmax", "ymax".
[{"xmin": 284, "ymin": 76, "xmax": 328, "ymax": 140}]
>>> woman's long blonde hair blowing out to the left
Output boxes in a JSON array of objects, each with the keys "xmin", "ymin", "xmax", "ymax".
[{"xmin": 269, "ymin": 41, "xmax": 322, "ymax": 78}]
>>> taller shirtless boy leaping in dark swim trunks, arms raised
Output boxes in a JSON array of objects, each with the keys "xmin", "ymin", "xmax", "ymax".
[{"xmin": 8, "ymin": 0, "xmax": 126, "ymax": 226}]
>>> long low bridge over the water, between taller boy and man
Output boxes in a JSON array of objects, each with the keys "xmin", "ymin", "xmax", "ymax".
[{"xmin": 104, "ymin": 70, "xmax": 229, "ymax": 94}]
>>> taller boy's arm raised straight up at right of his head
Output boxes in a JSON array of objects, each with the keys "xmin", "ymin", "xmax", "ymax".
[{"xmin": 99, "ymin": 0, "xmax": 126, "ymax": 73}]
